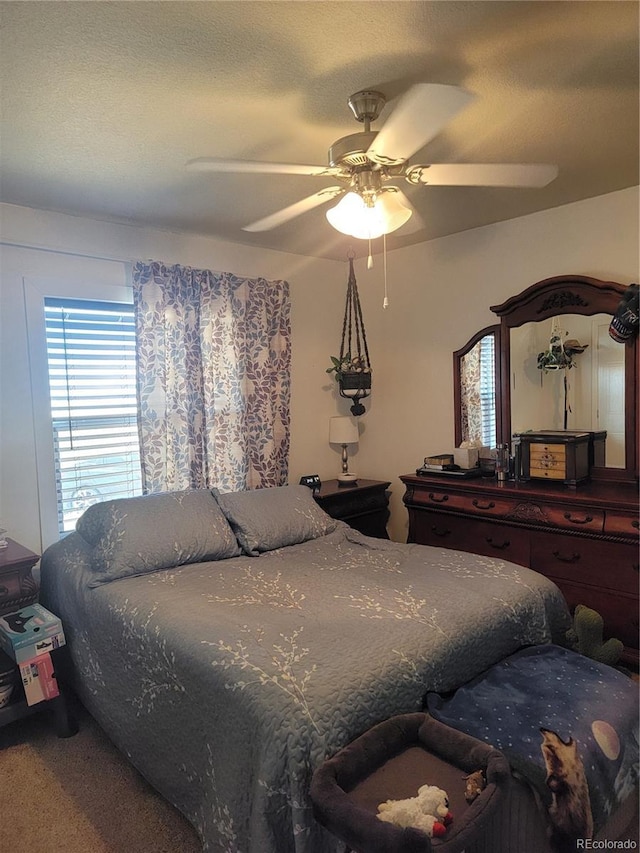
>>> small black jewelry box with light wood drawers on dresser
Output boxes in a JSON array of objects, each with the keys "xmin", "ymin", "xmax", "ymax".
[{"xmin": 515, "ymin": 430, "xmax": 600, "ymax": 486}]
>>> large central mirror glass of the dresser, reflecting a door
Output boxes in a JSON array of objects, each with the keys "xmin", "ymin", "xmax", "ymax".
[{"xmin": 510, "ymin": 314, "xmax": 625, "ymax": 468}]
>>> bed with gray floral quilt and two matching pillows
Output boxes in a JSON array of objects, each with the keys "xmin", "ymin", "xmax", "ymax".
[{"xmin": 40, "ymin": 486, "xmax": 570, "ymax": 853}]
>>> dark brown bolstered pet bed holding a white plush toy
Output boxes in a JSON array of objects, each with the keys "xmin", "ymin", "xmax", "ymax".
[{"xmin": 311, "ymin": 713, "xmax": 510, "ymax": 853}]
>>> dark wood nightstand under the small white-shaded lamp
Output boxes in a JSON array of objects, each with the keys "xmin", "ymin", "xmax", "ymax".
[{"xmin": 314, "ymin": 479, "xmax": 391, "ymax": 539}]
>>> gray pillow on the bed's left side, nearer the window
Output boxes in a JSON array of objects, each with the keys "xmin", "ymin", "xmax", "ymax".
[{"xmin": 76, "ymin": 489, "xmax": 241, "ymax": 587}]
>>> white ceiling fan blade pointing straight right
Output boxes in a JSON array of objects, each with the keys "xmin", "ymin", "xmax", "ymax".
[{"xmin": 405, "ymin": 163, "xmax": 558, "ymax": 187}]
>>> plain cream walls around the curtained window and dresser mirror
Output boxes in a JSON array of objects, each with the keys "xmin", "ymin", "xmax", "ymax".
[{"xmin": 0, "ymin": 183, "xmax": 639, "ymax": 550}]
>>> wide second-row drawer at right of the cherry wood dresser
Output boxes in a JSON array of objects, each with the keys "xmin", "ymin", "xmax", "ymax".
[{"xmin": 531, "ymin": 533, "xmax": 638, "ymax": 592}]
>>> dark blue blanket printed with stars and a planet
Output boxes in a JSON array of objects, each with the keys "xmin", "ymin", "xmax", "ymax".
[{"xmin": 427, "ymin": 645, "xmax": 638, "ymax": 849}]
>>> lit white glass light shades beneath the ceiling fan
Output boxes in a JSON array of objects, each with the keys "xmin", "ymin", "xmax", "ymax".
[{"xmin": 326, "ymin": 191, "xmax": 411, "ymax": 240}]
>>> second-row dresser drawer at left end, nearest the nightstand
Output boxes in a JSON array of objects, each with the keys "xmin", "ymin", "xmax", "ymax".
[{"xmin": 410, "ymin": 512, "xmax": 529, "ymax": 566}]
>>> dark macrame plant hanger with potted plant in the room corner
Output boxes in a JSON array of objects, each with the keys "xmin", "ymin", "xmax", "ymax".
[{"xmin": 338, "ymin": 253, "xmax": 371, "ymax": 416}]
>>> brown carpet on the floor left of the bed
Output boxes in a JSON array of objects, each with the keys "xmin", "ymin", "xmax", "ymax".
[{"xmin": 0, "ymin": 692, "xmax": 202, "ymax": 853}]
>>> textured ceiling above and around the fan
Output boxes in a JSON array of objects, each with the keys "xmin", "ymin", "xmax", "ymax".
[{"xmin": 0, "ymin": 0, "xmax": 639, "ymax": 259}]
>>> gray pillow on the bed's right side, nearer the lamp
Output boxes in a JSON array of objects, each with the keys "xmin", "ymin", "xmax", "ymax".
[{"xmin": 213, "ymin": 486, "xmax": 338, "ymax": 557}]
